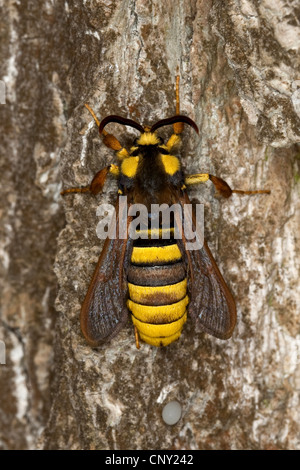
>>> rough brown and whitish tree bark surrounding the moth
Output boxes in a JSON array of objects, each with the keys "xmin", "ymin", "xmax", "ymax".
[{"xmin": 0, "ymin": 0, "xmax": 300, "ymax": 449}]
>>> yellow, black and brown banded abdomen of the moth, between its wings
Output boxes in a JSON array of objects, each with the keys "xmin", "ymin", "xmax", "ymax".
[{"xmin": 127, "ymin": 238, "xmax": 188, "ymax": 346}]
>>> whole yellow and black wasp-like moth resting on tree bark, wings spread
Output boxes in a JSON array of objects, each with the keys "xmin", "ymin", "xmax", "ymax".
[{"xmin": 62, "ymin": 76, "xmax": 270, "ymax": 348}]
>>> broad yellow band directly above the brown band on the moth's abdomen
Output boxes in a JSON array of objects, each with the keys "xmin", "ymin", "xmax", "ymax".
[{"xmin": 131, "ymin": 244, "xmax": 181, "ymax": 264}]
